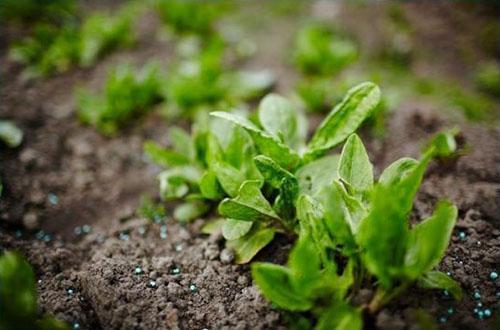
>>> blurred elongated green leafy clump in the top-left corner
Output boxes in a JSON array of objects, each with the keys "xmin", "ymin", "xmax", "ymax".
[{"xmin": 10, "ymin": 7, "xmax": 135, "ymax": 77}]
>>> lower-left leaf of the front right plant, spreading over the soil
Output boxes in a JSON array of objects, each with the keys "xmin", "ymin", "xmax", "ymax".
[{"xmin": 252, "ymin": 262, "xmax": 312, "ymax": 311}]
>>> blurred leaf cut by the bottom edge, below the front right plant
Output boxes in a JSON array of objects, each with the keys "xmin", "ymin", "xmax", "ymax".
[{"xmin": 315, "ymin": 301, "xmax": 363, "ymax": 330}]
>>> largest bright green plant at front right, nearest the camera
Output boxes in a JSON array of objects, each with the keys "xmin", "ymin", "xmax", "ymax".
[{"xmin": 252, "ymin": 131, "xmax": 461, "ymax": 329}]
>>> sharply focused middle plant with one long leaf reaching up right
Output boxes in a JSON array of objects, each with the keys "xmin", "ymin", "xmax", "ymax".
[{"xmin": 212, "ymin": 83, "xmax": 380, "ymax": 263}]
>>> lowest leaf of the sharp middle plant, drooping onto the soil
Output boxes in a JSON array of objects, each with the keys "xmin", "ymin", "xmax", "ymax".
[{"xmin": 226, "ymin": 228, "xmax": 276, "ymax": 264}]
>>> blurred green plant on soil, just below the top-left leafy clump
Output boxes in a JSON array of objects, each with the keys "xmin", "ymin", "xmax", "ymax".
[{"xmin": 76, "ymin": 62, "xmax": 163, "ymax": 135}]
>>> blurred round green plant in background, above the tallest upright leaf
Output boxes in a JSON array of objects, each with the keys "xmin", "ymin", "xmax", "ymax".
[{"xmin": 293, "ymin": 25, "xmax": 358, "ymax": 76}]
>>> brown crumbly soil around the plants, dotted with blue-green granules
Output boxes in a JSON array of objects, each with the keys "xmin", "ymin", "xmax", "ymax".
[{"xmin": 0, "ymin": 0, "xmax": 500, "ymax": 329}]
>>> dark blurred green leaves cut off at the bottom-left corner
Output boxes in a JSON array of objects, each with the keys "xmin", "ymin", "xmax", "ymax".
[{"xmin": 0, "ymin": 252, "xmax": 69, "ymax": 330}]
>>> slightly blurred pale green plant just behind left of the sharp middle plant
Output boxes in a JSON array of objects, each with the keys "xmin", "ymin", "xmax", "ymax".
[{"xmin": 144, "ymin": 113, "xmax": 261, "ymax": 221}]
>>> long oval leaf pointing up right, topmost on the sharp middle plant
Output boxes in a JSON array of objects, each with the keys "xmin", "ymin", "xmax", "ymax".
[{"xmin": 304, "ymin": 82, "xmax": 380, "ymax": 159}]
